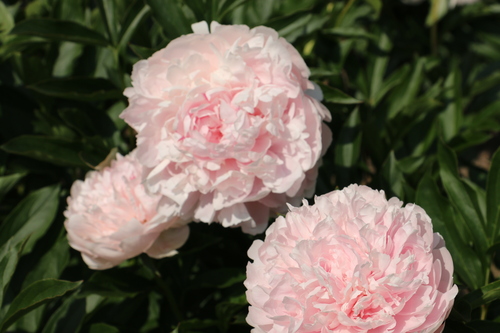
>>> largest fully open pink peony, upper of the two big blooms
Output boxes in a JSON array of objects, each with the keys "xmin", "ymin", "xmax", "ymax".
[{"xmin": 121, "ymin": 22, "xmax": 330, "ymax": 233}]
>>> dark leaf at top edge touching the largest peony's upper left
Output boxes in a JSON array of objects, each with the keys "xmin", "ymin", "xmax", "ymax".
[{"xmin": 145, "ymin": 0, "xmax": 196, "ymax": 39}]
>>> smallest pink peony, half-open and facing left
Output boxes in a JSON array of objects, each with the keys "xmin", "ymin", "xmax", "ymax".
[{"xmin": 64, "ymin": 151, "xmax": 189, "ymax": 269}]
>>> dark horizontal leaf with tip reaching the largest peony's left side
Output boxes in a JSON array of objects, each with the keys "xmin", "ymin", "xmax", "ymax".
[{"xmin": 28, "ymin": 77, "xmax": 122, "ymax": 102}]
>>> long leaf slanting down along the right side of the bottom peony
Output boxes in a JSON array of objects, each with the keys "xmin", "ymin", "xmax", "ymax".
[{"xmin": 416, "ymin": 174, "xmax": 485, "ymax": 289}]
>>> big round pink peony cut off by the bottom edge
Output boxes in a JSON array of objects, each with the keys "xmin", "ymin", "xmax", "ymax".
[{"xmin": 245, "ymin": 185, "xmax": 458, "ymax": 333}]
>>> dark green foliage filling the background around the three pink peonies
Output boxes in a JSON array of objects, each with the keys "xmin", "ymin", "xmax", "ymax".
[{"xmin": 0, "ymin": 0, "xmax": 500, "ymax": 333}]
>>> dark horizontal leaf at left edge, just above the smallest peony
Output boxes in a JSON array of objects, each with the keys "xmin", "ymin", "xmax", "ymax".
[{"xmin": 1, "ymin": 135, "xmax": 85, "ymax": 166}]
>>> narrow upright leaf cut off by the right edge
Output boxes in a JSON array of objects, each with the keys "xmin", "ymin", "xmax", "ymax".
[{"xmin": 486, "ymin": 149, "xmax": 500, "ymax": 240}]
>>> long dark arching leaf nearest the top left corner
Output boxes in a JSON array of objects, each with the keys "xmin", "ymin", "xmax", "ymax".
[{"xmin": 10, "ymin": 18, "xmax": 108, "ymax": 46}]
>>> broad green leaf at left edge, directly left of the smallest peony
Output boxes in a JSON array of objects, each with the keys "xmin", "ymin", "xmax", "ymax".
[{"xmin": 0, "ymin": 186, "xmax": 59, "ymax": 253}]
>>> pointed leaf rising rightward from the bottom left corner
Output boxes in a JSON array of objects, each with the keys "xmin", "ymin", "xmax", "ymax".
[{"xmin": 0, "ymin": 279, "xmax": 82, "ymax": 332}]
